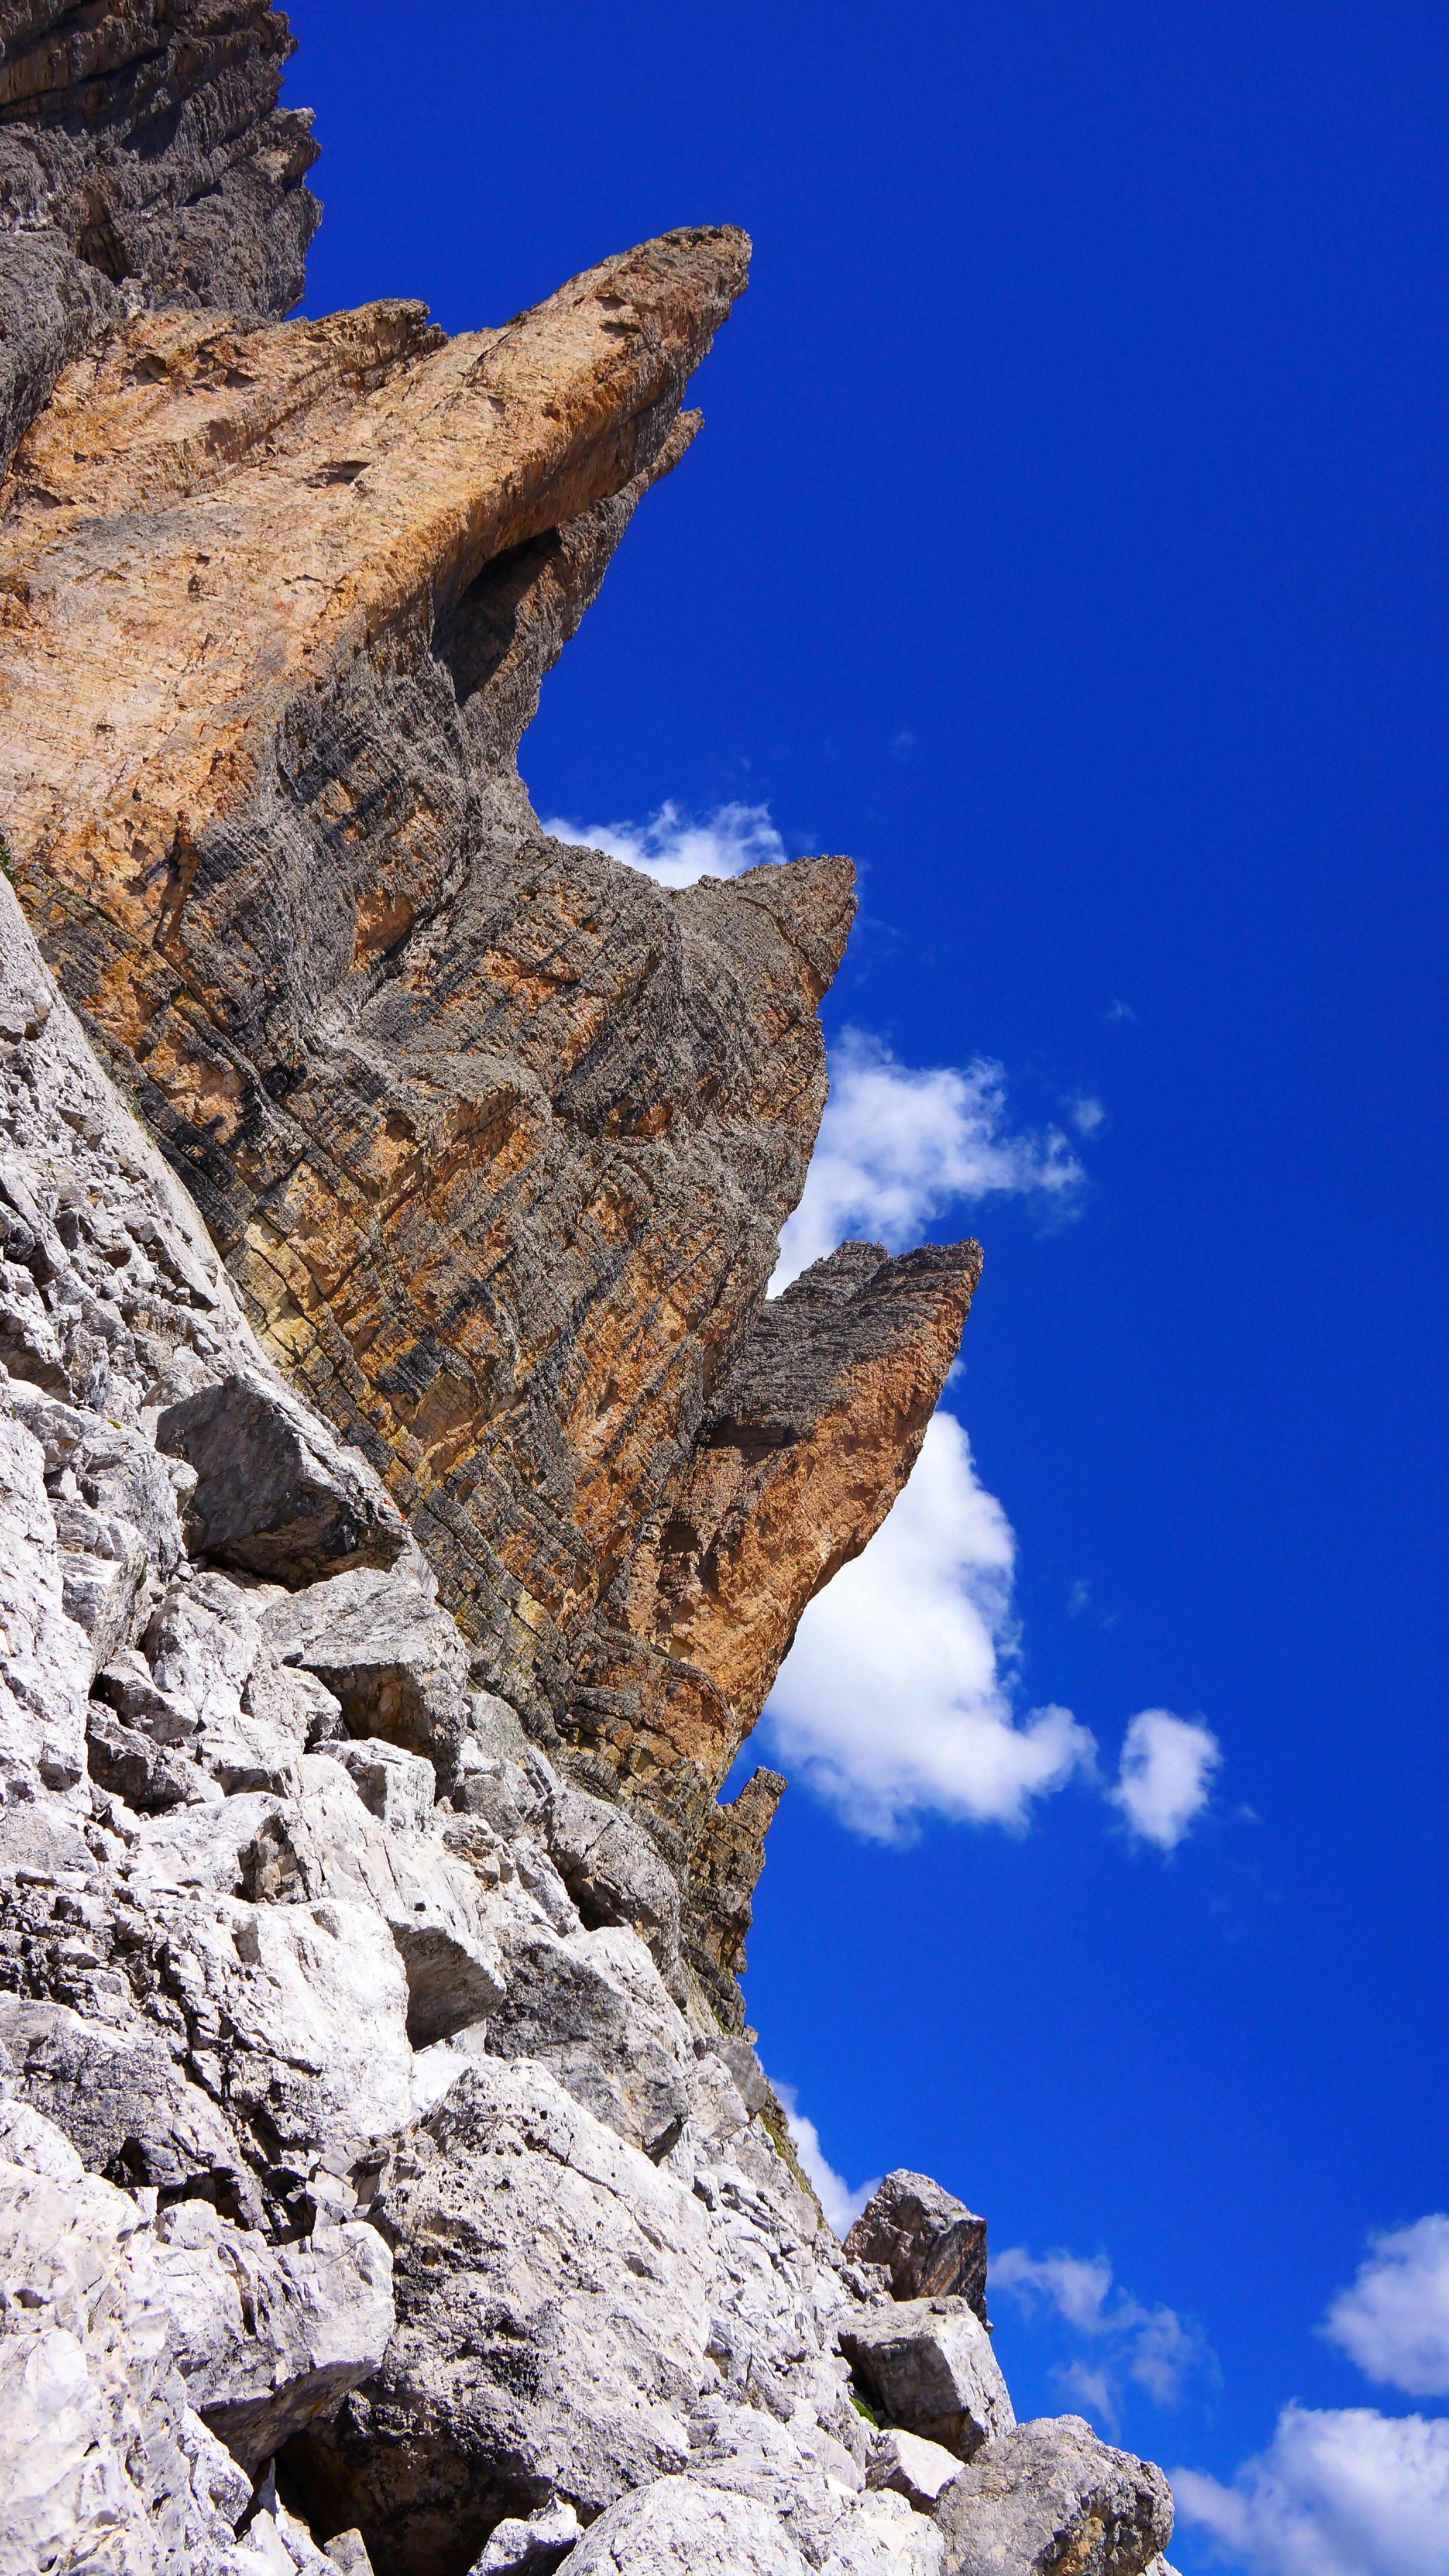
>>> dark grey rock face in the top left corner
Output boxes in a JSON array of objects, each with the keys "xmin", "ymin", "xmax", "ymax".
[{"xmin": 0, "ymin": 0, "xmax": 322, "ymax": 471}]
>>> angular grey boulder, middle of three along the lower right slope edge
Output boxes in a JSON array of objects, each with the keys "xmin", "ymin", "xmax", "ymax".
[{"xmin": 839, "ymin": 2298, "xmax": 1017, "ymax": 2460}]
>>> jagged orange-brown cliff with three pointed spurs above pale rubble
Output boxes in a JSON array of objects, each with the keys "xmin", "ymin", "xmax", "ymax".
[{"xmin": 0, "ymin": 229, "xmax": 976, "ymax": 1917}]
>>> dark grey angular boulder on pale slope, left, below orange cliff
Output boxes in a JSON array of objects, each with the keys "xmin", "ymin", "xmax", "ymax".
[{"xmin": 157, "ymin": 1376, "xmax": 409, "ymax": 1589}]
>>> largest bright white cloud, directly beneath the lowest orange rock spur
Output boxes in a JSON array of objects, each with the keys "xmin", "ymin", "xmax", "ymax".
[{"xmin": 767, "ymin": 1412, "xmax": 1096, "ymax": 1842}]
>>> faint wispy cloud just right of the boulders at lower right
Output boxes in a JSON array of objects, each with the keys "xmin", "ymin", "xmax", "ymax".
[{"xmin": 991, "ymin": 2246, "xmax": 1217, "ymax": 2429}]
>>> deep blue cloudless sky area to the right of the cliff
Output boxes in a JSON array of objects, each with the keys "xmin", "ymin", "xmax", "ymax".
[{"xmin": 288, "ymin": 0, "xmax": 1449, "ymax": 2571}]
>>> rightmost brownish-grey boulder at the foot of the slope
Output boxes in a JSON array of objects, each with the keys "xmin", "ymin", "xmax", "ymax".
[{"xmin": 934, "ymin": 2416, "xmax": 1173, "ymax": 2576}]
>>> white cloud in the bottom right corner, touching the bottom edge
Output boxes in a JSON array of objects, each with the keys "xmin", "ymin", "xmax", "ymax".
[{"xmin": 1171, "ymin": 2406, "xmax": 1449, "ymax": 2576}]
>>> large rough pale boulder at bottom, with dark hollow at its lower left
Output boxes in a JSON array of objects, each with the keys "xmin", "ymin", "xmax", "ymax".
[{"xmin": 288, "ymin": 2061, "xmax": 715, "ymax": 2576}]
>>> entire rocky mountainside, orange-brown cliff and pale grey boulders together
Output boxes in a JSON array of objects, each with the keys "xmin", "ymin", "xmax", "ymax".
[{"xmin": 0, "ymin": 0, "xmax": 1171, "ymax": 2576}]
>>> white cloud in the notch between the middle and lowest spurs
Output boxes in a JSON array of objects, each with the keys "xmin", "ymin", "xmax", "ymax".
[{"xmin": 770, "ymin": 1028, "xmax": 1084, "ymax": 1293}]
